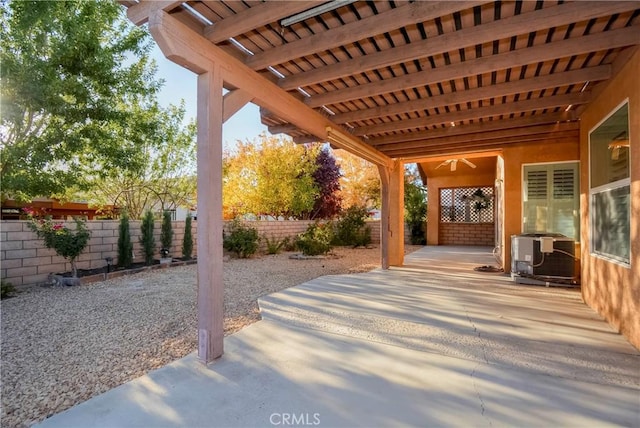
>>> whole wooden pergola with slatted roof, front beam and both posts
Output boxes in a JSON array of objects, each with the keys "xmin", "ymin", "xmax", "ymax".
[{"xmin": 120, "ymin": 0, "xmax": 640, "ymax": 363}]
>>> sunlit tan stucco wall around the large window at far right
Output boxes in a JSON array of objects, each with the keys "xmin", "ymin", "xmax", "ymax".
[{"xmin": 580, "ymin": 50, "xmax": 640, "ymax": 348}]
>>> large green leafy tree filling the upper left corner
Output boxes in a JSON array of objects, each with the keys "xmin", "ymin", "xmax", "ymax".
[{"xmin": 0, "ymin": 0, "xmax": 161, "ymax": 200}]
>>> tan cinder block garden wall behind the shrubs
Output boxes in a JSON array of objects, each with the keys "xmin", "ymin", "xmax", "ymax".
[{"xmin": 0, "ymin": 220, "xmax": 380, "ymax": 286}]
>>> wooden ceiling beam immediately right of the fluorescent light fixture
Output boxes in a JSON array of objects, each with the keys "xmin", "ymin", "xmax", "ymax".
[{"xmin": 245, "ymin": 0, "xmax": 480, "ymax": 70}]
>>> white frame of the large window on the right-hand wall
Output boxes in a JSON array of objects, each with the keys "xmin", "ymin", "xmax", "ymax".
[{"xmin": 587, "ymin": 98, "xmax": 632, "ymax": 269}]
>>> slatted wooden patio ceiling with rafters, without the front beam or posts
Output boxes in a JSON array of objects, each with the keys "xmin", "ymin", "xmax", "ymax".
[{"xmin": 121, "ymin": 1, "xmax": 640, "ymax": 161}]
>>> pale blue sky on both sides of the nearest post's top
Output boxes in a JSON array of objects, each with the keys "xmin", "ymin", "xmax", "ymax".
[{"xmin": 151, "ymin": 46, "xmax": 267, "ymax": 148}]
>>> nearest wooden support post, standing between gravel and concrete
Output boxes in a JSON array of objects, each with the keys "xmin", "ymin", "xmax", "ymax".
[{"xmin": 197, "ymin": 64, "xmax": 224, "ymax": 364}]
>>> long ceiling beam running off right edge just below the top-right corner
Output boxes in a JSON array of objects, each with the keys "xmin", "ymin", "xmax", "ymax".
[{"xmin": 305, "ymin": 25, "xmax": 640, "ymax": 107}]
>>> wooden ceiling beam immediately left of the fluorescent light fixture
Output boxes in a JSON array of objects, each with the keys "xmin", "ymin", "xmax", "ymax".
[{"xmin": 204, "ymin": 0, "xmax": 324, "ymax": 43}]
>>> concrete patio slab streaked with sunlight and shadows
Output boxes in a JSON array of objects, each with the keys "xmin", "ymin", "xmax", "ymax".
[{"xmin": 38, "ymin": 247, "xmax": 640, "ymax": 427}]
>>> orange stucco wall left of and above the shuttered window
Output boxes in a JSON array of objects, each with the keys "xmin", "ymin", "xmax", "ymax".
[{"xmin": 502, "ymin": 141, "xmax": 579, "ymax": 272}]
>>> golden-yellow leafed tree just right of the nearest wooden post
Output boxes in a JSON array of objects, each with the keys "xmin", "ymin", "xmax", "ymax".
[{"xmin": 223, "ymin": 134, "xmax": 319, "ymax": 218}]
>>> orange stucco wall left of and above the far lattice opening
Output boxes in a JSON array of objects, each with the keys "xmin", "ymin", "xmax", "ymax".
[{"xmin": 427, "ymin": 170, "xmax": 496, "ymax": 245}]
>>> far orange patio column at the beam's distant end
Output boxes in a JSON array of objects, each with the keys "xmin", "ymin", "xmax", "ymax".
[{"xmin": 378, "ymin": 160, "xmax": 404, "ymax": 269}]
